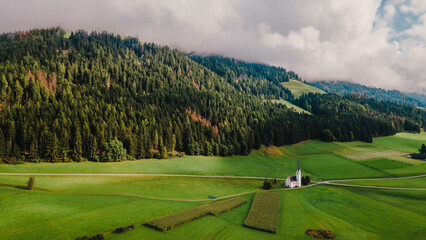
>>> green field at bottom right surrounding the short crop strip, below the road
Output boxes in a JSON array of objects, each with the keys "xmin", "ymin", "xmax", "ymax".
[{"xmin": 107, "ymin": 186, "xmax": 426, "ymax": 240}]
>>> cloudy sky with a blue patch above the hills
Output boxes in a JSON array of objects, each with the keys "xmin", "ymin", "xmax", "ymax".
[{"xmin": 0, "ymin": 0, "xmax": 426, "ymax": 93}]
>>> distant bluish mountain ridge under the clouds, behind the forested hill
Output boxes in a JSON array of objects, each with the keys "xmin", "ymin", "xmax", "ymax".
[{"xmin": 311, "ymin": 81, "xmax": 426, "ymax": 107}]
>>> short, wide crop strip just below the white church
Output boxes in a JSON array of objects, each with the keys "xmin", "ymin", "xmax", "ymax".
[{"xmin": 243, "ymin": 192, "xmax": 281, "ymax": 233}]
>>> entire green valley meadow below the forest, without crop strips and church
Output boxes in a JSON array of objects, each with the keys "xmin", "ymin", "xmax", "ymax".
[{"xmin": 0, "ymin": 132, "xmax": 426, "ymax": 239}]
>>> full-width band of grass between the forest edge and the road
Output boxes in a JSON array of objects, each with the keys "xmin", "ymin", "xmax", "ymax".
[{"xmin": 0, "ymin": 132, "xmax": 426, "ymax": 179}]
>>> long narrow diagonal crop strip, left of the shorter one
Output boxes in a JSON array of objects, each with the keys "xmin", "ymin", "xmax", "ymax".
[{"xmin": 144, "ymin": 197, "xmax": 247, "ymax": 232}]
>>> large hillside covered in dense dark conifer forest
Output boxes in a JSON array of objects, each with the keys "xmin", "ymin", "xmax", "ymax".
[{"xmin": 0, "ymin": 28, "xmax": 426, "ymax": 163}]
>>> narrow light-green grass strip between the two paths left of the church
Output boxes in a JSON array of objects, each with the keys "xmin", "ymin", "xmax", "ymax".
[{"xmin": 0, "ymin": 176, "xmax": 263, "ymax": 199}]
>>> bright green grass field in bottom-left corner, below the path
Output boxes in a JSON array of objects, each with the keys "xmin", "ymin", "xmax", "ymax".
[{"xmin": 0, "ymin": 187, "xmax": 201, "ymax": 239}]
